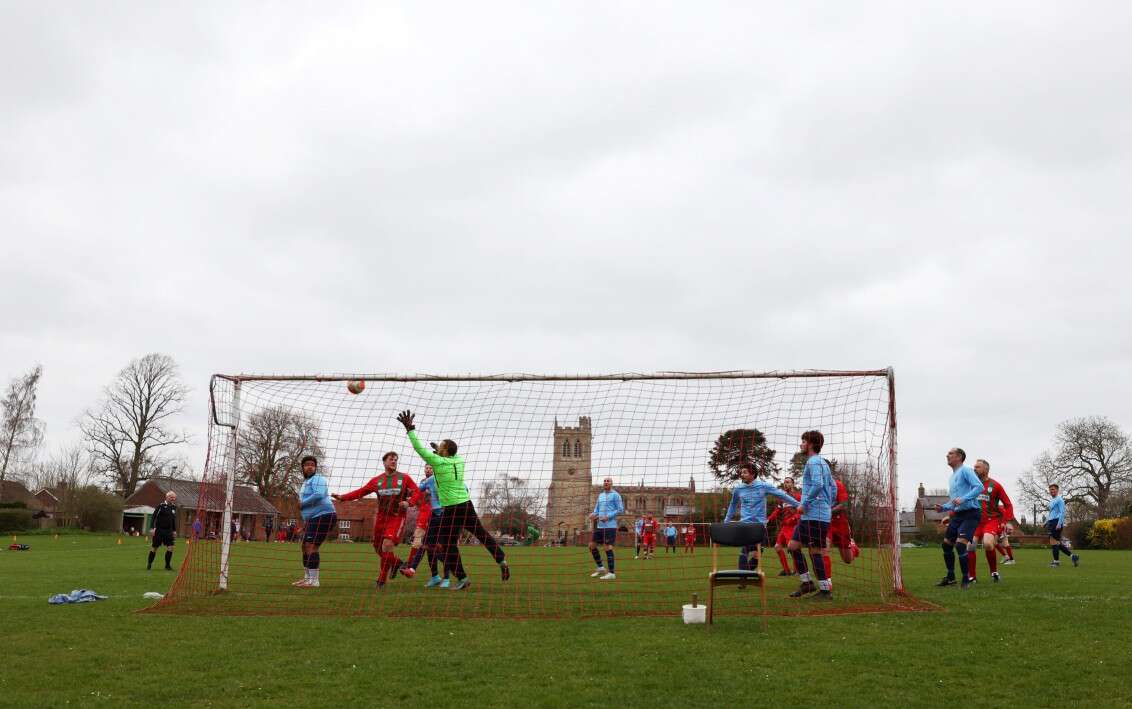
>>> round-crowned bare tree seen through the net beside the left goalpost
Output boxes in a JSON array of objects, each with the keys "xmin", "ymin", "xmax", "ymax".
[{"xmin": 235, "ymin": 407, "xmax": 323, "ymax": 497}]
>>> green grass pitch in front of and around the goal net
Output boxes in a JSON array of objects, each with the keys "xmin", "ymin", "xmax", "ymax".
[{"xmin": 0, "ymin": 535, "xmax": 1132, "ymax": 707}]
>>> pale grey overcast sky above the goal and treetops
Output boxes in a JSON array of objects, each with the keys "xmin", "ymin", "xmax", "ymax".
[{"xmin": 0, "ymin": 2, "xmax": 1132, "ymax": 514}]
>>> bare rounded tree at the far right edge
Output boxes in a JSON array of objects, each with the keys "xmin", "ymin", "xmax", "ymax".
[{"xmin": 1021, "ymin": 416, "xmax": 1132, "ymax": 519}]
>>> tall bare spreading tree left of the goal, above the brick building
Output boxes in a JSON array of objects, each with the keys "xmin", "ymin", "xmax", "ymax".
[{"xmin": 80, "ymin": 353, "xmax": 188, "ymax": 497}]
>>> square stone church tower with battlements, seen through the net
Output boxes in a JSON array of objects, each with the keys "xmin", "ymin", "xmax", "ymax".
[{"xmin": 547, "ymin": 416, "xmax": 593, "ymax": 540}]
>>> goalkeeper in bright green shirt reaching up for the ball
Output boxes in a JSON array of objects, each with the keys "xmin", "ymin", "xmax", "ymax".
[{"xmin": 397, "ymin": 411, "xmax": 511, "ymax": 591}]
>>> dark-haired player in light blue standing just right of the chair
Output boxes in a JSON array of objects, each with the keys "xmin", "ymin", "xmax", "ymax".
[{"xmin": 787, "ymin": 430, "xmax": 838, "ymax": 600}]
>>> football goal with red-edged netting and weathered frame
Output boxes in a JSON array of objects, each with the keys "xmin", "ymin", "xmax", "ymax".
[{"xmin": 153, "ymin": 368, "xmax": 923, "ymax": 617}]
